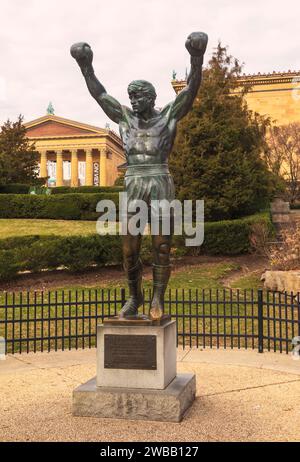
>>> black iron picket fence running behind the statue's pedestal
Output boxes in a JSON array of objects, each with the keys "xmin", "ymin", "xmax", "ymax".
[{"xmin": 0, "ymin": 289, "xmax": 300, "ymax": 353}]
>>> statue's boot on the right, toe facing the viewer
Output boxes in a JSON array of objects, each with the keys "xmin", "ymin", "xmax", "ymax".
[{"xmin": 149, "ymin": 264, "xmax": 171, "ymax": 320}]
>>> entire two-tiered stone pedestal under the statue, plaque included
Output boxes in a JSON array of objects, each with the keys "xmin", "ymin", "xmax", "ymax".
[{"xmin": 73, "ymin": 319, "xmax": 196, "ymax": 422}]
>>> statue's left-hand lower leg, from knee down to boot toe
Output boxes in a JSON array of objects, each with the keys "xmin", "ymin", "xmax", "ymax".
[{"xmin": 119, "ymin": 234, "xmax": 143, "ymax": 318}]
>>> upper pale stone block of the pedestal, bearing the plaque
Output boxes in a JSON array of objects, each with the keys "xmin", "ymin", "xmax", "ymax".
[{"xmin": 97, "ymin": 321, "xmax": 176, "ymax": 390}]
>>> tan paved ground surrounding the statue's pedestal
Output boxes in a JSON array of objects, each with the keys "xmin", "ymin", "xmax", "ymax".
[{"xmin": 0, "ymin": 349, "xmax": 300, "ymax": 441}]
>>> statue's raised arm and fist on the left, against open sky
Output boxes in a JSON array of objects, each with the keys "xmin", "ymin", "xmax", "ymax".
[{"xmin": 70, "ymin": 42, "xmax": 122, "ymax": 124}]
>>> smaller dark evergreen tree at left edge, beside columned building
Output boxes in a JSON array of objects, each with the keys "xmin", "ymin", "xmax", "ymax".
[{"xmin": 0, "ymin": 115, "xmax": 40, "ymax": 185}]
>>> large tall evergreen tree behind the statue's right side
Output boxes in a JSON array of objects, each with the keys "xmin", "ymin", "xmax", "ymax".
[{"xmin": 170, "ymin": 43, "xmax": 276, "ymax": 220}]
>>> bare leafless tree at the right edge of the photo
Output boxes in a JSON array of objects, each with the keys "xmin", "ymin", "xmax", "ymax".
[{"xmin": 265, "ymin": 122, "xmax": 300, "ymax": 204}]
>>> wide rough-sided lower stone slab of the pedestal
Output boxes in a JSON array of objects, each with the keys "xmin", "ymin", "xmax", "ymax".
[{"xmin": 73, "ymin": 374, "xmax": 196, "ymax": 422}]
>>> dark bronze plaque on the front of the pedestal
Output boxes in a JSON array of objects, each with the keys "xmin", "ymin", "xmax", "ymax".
[{"xmin": 104, "ymin": 334, "xmax": 157, "ymax": 370}]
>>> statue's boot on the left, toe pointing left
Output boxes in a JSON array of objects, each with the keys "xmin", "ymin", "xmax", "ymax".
[{"xmin": 119, "ymin": 260, "xmax": 144, "ymax": 318}]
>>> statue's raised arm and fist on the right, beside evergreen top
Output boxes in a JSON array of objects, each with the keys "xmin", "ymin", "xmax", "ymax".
[{"xmin": 171, "ymin": 32, "xmax": 208, "ymax": 120}]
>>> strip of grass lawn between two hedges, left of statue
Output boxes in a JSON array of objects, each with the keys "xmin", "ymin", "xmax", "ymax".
[{"xmin": 0, "ymin": 218, "xmax": 96, "ymax": 239}]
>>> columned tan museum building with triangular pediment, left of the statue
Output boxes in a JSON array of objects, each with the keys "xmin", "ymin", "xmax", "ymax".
[{"xmin": 24, "ymin": 113, "xmax": 126, "ymax": 187}]
